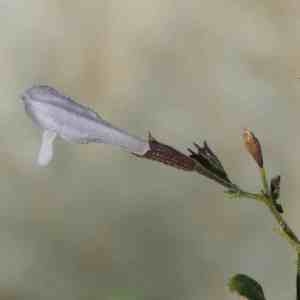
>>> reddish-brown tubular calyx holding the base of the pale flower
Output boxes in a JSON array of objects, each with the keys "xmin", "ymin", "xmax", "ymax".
[{"xmin": 135, "ymin": 133, "xmax": 195, "ymax": 171}]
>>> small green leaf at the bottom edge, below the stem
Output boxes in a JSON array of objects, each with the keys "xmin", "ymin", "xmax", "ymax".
[{"xmin": 228, "ymin": 274, "xmax": 266, "ymax": 300}]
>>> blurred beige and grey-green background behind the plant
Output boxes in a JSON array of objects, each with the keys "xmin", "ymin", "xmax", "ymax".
[{"xmin": 0, "ymin": 0, "xmax": 300, "ymax": 300}]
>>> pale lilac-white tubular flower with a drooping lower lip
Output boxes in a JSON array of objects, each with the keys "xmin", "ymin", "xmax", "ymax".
[{"xmin": 21, "ymin": 86, "xmax": 149, "ymax": 166}]
